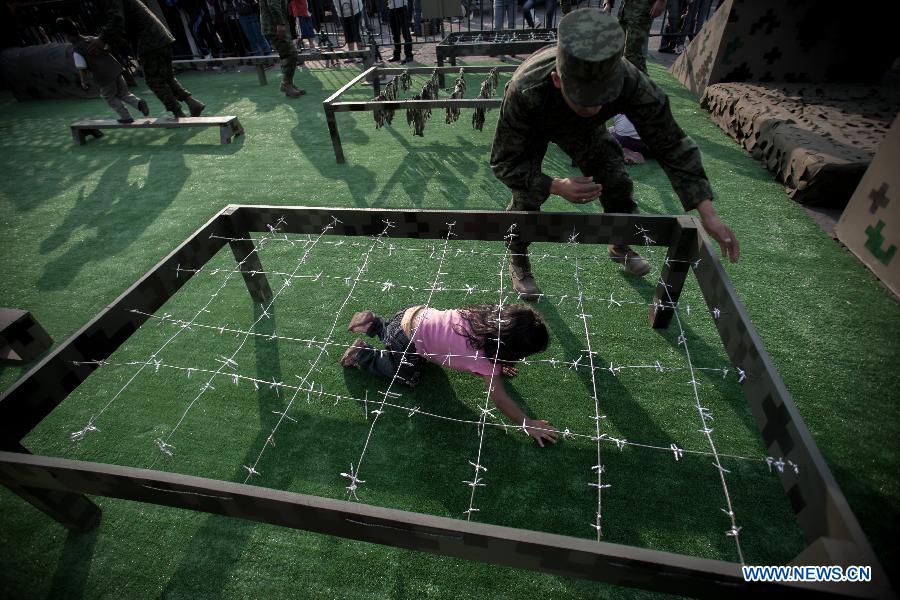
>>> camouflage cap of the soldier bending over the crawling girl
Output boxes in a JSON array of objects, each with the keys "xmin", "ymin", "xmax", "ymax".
[{"xmin": 556, "ymin": 8, "xmax": 625, "ymax": 106}]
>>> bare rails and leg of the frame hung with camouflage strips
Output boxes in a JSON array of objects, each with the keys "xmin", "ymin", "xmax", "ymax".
[{"xmin": 322, "ymin": 65, "xmax": 518, "ymax": 164}]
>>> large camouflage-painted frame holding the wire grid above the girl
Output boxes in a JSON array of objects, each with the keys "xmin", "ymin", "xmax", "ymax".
[{"xmin": 0, "ymin": 205, "xmax": 893, "ymax": 598}]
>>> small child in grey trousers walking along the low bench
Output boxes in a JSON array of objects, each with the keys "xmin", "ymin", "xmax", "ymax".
[{"xmin": 56, "ymin": 18, "xmax": 150, "ymax": 124}]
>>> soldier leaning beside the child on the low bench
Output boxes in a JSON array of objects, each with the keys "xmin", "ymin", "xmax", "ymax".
[{"xmin": 88, "ymin": 0, "xmax": 205, "ymax": 118}]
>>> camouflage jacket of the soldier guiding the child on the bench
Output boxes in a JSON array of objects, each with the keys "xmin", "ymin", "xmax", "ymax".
[{"xmin": 95, "ymin": 0, "xmax": 175, "ymax": 56}]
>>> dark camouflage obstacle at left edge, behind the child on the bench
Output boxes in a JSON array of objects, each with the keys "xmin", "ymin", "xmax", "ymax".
[{"xmin": 0, "ymin": 44, "xmax": 100, "ymax": 102}]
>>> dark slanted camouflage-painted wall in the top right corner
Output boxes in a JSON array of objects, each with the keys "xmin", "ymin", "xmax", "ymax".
[{"xmin": 672, "ymin": 0, "xmax": 900, "ymax": 96}]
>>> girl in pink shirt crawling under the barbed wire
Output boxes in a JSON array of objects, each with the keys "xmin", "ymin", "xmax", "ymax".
[{"xmin": 341, "ymin": 304, "xmax": 556, "ymax": 448}]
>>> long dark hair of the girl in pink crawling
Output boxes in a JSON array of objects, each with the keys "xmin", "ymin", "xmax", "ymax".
[{"xmin": 457, "ymin": 304, "xmax": 550, "ymax": 362}]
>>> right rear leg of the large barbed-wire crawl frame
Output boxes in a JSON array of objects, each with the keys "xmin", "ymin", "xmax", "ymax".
[{"xmin": 650, "ymin": 217, "xmax": 700, "ymax": 329}]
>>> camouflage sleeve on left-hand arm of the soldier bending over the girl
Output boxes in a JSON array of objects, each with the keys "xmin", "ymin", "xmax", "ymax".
[{"xmin": 491, "ymin": 85, "xmax": 553, "ymax": 196}]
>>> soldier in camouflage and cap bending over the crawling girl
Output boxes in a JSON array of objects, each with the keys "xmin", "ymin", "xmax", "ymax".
[{"xmin": 491, "ymin": 9, "xmax": 740, "ymax": 300}]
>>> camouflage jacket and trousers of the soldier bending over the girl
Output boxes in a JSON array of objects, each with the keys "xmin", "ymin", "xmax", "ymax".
[{"xmin": 491, "ymin": 46, "xmax": 712, "ymax": 244}]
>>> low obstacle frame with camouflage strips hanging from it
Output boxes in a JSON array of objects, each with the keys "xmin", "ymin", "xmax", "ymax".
[{"xmin": 322, "ymin": 65, "xmax": 518, "ymax": 164}]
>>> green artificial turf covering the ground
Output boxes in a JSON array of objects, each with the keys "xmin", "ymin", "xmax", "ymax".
[{"xmin": 0, "ymin": 57, "xmax": 900, "ymax": 598}]
